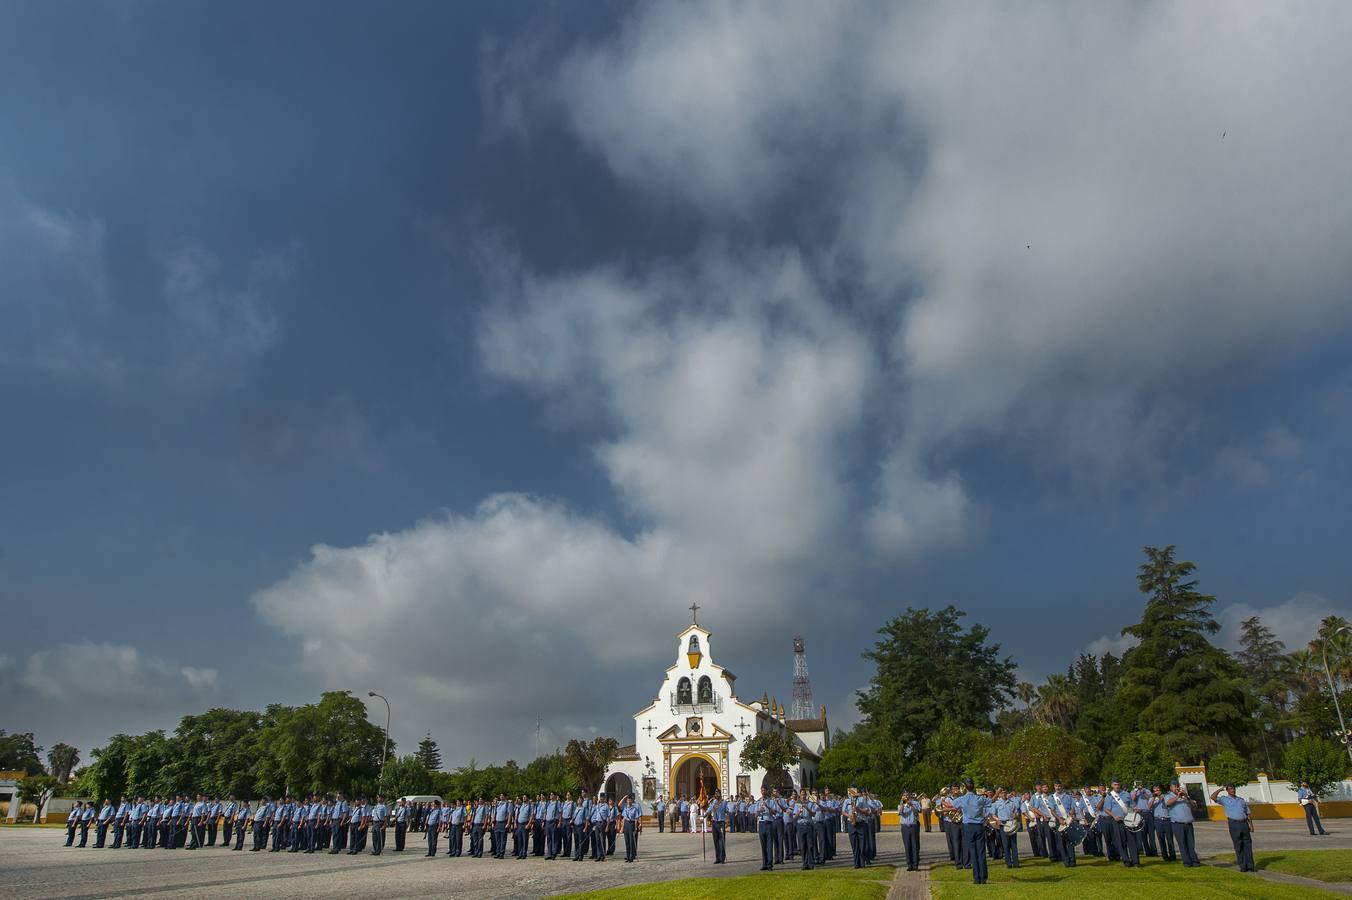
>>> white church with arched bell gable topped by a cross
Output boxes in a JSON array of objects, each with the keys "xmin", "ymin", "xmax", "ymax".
[{"xmin": 603, "ymin": 608, "xmax": 830, "ymax": 801}]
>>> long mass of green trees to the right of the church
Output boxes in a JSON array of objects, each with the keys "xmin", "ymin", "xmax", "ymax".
[{"xmin": 819, "ymin": 546, "xmax": 1352, "ymax": 801}]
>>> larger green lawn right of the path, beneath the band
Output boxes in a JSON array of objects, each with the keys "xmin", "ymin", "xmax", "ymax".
[{"xmin": 930, "ymin": 851, "xmax": 1330, "ymax": 900}]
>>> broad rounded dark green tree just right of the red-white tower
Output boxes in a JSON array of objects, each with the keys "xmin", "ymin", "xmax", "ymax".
[{"xmin": 859, "ymin": 607, "xmax": 1014, "ymax": 762}]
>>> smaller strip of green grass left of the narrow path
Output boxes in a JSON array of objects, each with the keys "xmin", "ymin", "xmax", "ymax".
[{"xmin": 568, "ymin": 866, "xmax": 895, "ymax": 900}]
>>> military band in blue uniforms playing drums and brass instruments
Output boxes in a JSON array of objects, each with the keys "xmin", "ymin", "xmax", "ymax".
[{"xmin": 924, "ymin": 780, "xmax": 1260, "ymax": 884}]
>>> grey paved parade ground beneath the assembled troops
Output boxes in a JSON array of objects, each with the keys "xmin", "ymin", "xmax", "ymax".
[{"xmin": 0, "ymin": 820, "xmax": 1352, "ymax": 900}]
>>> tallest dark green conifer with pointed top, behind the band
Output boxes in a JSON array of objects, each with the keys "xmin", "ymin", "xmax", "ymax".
[{"xmin": 1117, "ymin": 546, "xmax": 1252, "ymax": 758}]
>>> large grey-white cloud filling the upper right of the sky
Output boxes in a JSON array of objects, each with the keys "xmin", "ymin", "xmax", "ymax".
[{"xmin": 539, "ymin": 0, "xmax": 1352, "ymax": 497}]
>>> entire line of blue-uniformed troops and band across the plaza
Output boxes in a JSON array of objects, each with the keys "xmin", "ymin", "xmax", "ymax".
[{"xmin": 58, "ymin": 780, "xmax": 1270, "ymax": 884}]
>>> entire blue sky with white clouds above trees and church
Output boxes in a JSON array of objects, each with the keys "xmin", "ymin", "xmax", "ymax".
[{"xmin": 0, "ymin": 1, "xmax": 1352, "ymax": 765}]
